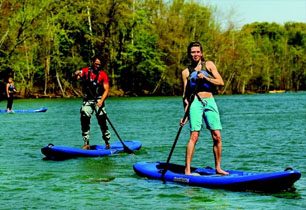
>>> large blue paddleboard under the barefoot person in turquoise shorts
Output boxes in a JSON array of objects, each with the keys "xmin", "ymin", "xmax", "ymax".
[{"xmin": 133, "ymin": 162, "xmax": 301, "ymax": 192}]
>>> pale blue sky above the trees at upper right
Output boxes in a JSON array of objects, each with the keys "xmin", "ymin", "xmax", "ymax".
[{"xmin": 201, "ymin": 0, "xmax": 306, "ymax": 28}]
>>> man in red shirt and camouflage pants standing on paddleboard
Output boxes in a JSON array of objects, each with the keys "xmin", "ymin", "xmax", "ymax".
[{"xmin": 75, "ymin": 56, "xmax": 111, "ymax": 149}]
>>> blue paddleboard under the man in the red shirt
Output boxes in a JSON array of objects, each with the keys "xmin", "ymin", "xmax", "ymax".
[{"xmin": 41, "ymin": 141, "xmax": 141, "ymax": 160}]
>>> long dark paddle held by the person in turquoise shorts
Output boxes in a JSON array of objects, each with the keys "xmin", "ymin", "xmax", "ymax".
[{"xmin": 161, "ymin": 80, "xmax": 201, "ymax": 184}]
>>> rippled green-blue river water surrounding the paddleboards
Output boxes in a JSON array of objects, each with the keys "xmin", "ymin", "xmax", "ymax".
[{"xmin": 0, "ymin": 92, "xmax": 306, "ymax": 210}]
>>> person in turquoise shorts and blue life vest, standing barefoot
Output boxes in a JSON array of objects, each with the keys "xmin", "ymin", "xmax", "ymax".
[{"xmin": 181, "ymin": 42, "xmax": 228, "ymax": 175}]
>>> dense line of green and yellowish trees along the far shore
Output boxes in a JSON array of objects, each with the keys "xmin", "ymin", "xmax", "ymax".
[{"xmin": 0, "ymin": 0, "xmax": 306, "ymax": 97}]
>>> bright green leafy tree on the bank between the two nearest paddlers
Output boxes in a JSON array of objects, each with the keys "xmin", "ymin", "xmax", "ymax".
[{"xmin": 119, "ymin": 8, "xmax": 165, "ymax": 94}]
